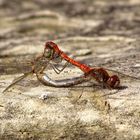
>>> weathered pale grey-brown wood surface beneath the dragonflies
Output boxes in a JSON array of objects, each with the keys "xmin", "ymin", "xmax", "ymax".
[{"xmin": 0, "ymin": 0, "xmax": 140, "ymax": 140}]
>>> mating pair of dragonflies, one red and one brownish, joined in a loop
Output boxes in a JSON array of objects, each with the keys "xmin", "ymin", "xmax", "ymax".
[{"xmin": 3, "ymin": 41, "xmax": 135, "ymax": 92}]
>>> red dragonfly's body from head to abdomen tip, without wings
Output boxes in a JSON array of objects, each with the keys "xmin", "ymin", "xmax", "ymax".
[{"xmin": 45, "ymin": 41, "xmax": 120, "ymax": 88}]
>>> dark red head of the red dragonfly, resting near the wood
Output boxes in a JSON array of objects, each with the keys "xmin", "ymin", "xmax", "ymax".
[{"xmin": 107, "ymin": 75, "xmax": 120, "ymax": 88}]
